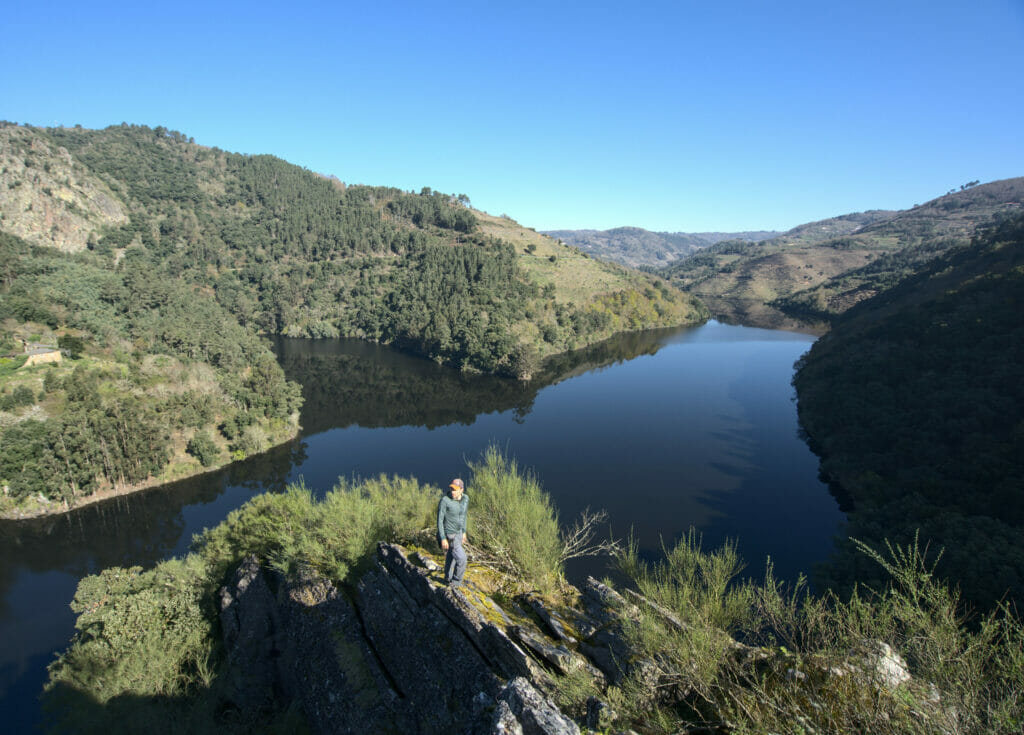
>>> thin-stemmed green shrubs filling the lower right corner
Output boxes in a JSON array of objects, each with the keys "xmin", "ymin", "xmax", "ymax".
[{"xmin": 608, "ymin": 531, "xmax": 1024, "ymax": 735}]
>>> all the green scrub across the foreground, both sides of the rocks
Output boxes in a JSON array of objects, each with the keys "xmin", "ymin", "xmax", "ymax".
[{"xmin": 44, "ymin": 449, "xmax": 1024, "ymax": 733}]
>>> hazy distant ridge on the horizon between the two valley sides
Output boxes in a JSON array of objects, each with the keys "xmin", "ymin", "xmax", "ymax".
[{"xmin": 544, "ymin": 227, "xmax": 780, "ymax": 268}]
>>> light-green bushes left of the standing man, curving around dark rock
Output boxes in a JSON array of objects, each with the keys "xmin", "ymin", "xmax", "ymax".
[{"xmin": 43, "ymin": 475, "xmax": 440, "ymax": 733}]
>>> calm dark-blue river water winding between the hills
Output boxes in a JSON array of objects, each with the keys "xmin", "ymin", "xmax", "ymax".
[{"xmin": 0, "ymin": 321, "xmax": 843, "ymax": 732}]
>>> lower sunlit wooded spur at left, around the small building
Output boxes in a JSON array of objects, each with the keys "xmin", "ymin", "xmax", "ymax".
[{"xmin": 0, "ymin": 232, "xmax": 301, "ymax": 504}]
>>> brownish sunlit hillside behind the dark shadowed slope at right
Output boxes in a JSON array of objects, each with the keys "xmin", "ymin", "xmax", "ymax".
[{"xmin": 658, "ymin": 178, "xmax": 1024, "ymax": 320}]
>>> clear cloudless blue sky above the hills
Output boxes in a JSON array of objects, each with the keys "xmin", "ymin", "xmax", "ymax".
[{"xmin": 0, "ymin": 0, "xmax": 1024, "ymax": 231}]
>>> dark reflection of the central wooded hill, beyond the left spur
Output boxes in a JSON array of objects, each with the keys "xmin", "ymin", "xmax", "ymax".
[{"xmin": 274, "ymin": 329, "xmax": 680, "ymax": 436}]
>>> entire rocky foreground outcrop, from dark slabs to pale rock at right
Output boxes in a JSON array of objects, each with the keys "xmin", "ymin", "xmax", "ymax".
[{"xmin": 220, "ymin": 544, "xmax": 956, "ymax": 735}]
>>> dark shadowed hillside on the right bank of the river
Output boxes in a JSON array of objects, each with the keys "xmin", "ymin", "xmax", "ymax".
[{"xmin": 794, "ymin": 215, "xmax": 1024, "ymax": 607}]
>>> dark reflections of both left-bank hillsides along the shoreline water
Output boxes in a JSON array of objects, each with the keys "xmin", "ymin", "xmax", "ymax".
[{"xmin": 0, "ymin": 330, "xmax": 678, "ymax": 620}]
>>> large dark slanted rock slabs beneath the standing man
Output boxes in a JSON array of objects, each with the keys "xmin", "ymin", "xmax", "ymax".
[{"xmin": 220, "ymin": 544, "xmax": 602, "ymax": 735}]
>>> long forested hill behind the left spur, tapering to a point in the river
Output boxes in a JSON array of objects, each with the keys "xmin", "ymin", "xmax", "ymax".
[{"xmin": 0, "ymin": 125, "xmax": 701, "ymax": 376}]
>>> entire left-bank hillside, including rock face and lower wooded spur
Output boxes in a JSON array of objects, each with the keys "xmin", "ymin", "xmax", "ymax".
[{"xmin": 0, "ymin": 124, "xmax": 707, "ymax": 515}]
